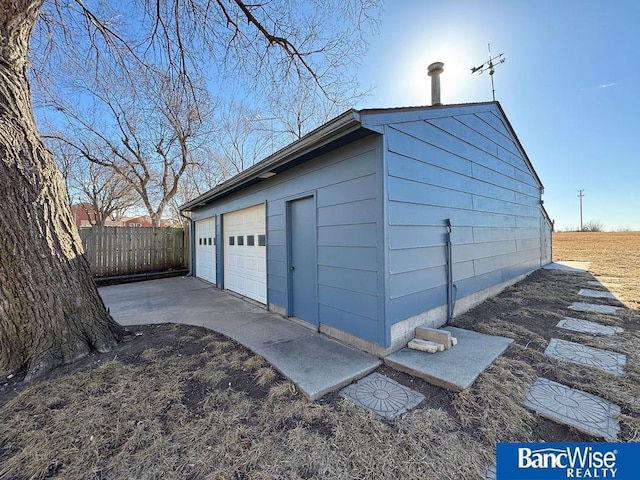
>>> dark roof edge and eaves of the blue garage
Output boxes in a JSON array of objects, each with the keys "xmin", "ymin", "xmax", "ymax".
[{"xmin": 180, "ymin": 102, "xmax": 543, "ymax": 211}]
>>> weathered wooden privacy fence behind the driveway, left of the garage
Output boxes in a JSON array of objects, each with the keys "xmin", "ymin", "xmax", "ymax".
[{"xmin": 80, "ymin": 226, "xmax": 188, "ymax": 277}]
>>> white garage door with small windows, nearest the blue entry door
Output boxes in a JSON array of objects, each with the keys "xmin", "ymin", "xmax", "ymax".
[{"xmin": 223, "ymin": 204, "xmax": 267, "ymax": 303}]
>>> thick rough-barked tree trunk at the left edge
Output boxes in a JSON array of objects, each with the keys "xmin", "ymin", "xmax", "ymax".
[{"xmin": 0, "ymin": 0, "xmax": 121, "ymax": 379}]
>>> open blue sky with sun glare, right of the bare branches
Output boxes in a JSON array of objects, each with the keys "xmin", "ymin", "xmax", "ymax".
[{"xmin": 358, "ymin": 0, "xmax": 640, "ymax": 230}]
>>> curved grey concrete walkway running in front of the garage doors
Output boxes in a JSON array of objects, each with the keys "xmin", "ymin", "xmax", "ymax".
[{"xmin": 99, "ymin": 277, "xmax": 381, "ymax": 400}]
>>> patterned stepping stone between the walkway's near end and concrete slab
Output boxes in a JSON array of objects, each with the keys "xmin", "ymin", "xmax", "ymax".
[{"xmin": 340, "ymin": 373, "xmax": 424, "ymax": 420}]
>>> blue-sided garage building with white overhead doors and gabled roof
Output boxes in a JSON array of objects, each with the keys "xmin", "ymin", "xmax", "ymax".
[{"xmin": 180, "ymin": 102, "xmax": 553, "ymax": 356}]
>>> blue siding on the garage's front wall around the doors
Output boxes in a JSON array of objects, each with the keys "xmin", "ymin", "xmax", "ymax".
[{"xmin": 193, "ymin": 135, "xmax": 385, "ymax": 344}]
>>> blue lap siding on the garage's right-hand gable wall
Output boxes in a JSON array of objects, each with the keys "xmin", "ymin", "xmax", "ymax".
[{"xmin": 385, "ymin": 107, "xmax": 542, "ymax": 324}]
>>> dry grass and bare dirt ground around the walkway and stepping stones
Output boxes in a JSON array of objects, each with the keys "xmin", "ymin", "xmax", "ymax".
[{"xmin": 0, "ymin": 233, "xmax": 640, "ymax": 480}]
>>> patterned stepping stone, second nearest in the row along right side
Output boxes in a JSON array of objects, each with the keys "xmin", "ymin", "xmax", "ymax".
[{"xmin": 544, "ymin": 338, "xmax": 627, "ymax": 377}]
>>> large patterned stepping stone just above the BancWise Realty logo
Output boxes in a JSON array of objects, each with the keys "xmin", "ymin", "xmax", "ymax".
[{"xmin": 524, "ymin": 378, "xmax": 620, "ymax": 440}]
